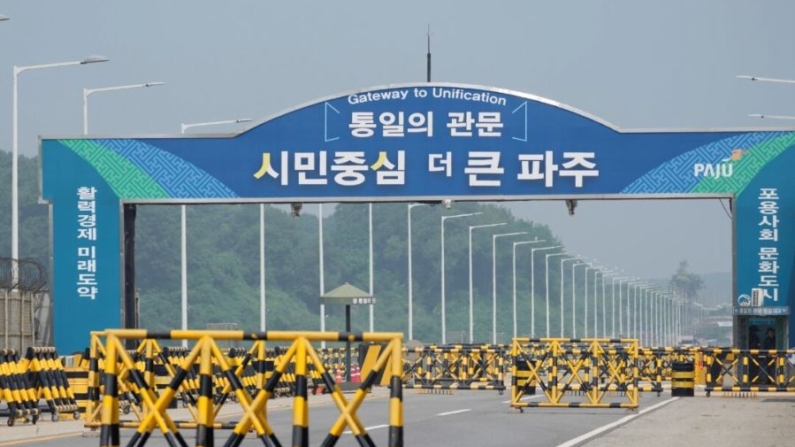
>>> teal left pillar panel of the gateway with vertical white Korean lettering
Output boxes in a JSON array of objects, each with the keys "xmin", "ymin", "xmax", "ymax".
[{"xmin": 42, "ymin": 143, "xmax": 121, "ymax": 353}]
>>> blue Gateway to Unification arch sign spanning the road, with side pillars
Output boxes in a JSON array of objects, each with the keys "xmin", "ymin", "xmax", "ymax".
[{"xmin": 41, "ymin": 83, "xmax": 795, "ymax": 349}]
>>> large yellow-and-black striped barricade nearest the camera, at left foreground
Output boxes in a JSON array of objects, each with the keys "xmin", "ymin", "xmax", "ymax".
[{"xmin": 86, "ymin": 330, "xmax": 403, "ymax": 446}]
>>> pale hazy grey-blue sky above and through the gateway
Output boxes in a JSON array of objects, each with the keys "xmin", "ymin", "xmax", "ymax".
[{"xmin": 0, "ymin": 0, "xmax": 795, "ymax": 277}]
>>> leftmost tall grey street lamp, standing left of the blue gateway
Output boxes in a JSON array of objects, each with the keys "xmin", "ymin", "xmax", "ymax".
[{"xmin": 11, "ymin": 56, "xmax": 108, "ymax": 284}]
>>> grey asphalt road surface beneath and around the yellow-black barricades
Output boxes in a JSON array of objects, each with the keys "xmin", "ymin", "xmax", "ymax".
[{"xmin": 0, "ymin": 390, "xmax": 669, "ymax": 447}]
